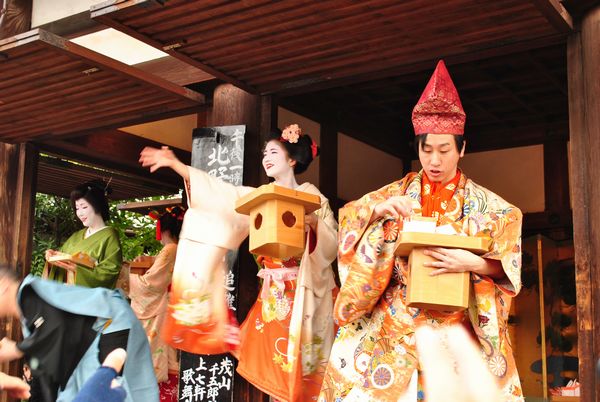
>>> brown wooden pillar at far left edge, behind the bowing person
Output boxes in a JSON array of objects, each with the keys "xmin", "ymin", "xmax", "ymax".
[{"xmin": 0, "ymin": 142, "xmax": 38, "ymax": 398}]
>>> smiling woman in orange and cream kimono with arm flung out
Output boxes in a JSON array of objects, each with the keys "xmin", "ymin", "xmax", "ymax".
[{"xmin": 140, "ymin": 125, "xmax": 337, "ymax": 401}]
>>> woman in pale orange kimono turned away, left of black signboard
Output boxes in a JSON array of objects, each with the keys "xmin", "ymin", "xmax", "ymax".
[{"xmin": 129, "ymin": 207, "xmax": 184, "ymax": 401}]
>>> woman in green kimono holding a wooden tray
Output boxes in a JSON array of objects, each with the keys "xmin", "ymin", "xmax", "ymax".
[{"xmin": 46, "ymin": 181, "xmax": 123, "ymax": 289}]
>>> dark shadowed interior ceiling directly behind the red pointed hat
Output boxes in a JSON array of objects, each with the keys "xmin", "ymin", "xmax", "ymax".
[{"xmin": 281, "ymin": 44, "xmax": 569, "ymax": 158}]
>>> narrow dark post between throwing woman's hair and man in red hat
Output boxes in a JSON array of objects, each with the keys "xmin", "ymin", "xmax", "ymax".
[{"xmin": 319, "ymin": 122, "xmax": 340, "ymax": 209}]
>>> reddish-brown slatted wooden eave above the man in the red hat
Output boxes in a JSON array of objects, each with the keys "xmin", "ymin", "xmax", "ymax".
[{"xmin": 92, "ymin": 0, "xmax": 572, "ymax": 94}]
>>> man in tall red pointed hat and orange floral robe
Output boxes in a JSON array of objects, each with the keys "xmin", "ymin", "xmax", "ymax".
[{"xmin": 319, "ymin": 62, "xmax": 523, "ymax": 402}]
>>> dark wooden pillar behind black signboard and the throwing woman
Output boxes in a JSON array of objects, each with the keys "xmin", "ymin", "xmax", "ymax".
[{"xmin": 212, "ymin": 84, "xmax": 277, "ymax": 402}]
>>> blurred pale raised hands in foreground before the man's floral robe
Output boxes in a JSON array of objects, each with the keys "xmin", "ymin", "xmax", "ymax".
[{"xmin": 416, "ymin": 325, "xmax": 503, "ymax": 402}]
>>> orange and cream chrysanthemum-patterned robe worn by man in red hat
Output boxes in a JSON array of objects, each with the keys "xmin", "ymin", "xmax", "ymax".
[{"xmin": 319, "ymin": 172, "xmax": 523, "ymax": 402}]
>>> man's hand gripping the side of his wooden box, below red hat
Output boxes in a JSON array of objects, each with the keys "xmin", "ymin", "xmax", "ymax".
[{"xmin": 423, "ymin": 247, "xmax": 485, "ymax": 276}]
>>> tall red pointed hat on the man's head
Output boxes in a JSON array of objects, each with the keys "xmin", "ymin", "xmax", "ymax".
[{"xmin": 412, "ymin": 60, "xmax": 466, "ymax": 135}]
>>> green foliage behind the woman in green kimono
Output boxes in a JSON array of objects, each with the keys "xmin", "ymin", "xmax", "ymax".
[{"xmin": 31, "ymin": 193, "xmax": 161, "ymax": 275}]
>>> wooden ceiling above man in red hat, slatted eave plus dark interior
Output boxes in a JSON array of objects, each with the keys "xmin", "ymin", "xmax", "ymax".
[{"xmin": 92, "ymin": 0, "xmax": 573, "ymax": 158}]
